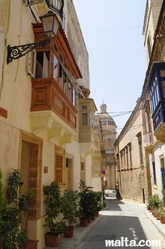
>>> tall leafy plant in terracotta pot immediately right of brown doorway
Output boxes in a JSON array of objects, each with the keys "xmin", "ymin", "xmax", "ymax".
[{"xmin": 43, "ymin": 181, "xmax": 67, "ymax": 247}]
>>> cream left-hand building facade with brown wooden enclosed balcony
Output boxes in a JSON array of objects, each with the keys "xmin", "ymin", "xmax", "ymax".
[{"xmin": 0, "ymin": 0, "xmax": 100, "ymax": 248}]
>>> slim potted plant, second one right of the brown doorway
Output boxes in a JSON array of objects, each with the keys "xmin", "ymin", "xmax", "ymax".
[{"xmin": 61, "ymin": 189, "xmax": 80, "ymax": 238}]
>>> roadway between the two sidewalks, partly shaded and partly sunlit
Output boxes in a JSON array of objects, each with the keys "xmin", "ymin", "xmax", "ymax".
[{"xmin": 76, "ymin": 199, "xmax": 165, "ymax": 249}]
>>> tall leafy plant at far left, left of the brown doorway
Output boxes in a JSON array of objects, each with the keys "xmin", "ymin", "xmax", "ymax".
[{"xmin": 1, "ymin": 169, "xmax": 34, "ymax": 249}]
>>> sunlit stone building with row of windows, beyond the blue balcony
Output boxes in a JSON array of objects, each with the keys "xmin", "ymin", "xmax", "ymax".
[{"xmin": 115, "ymin": 99, "xmax": 148, "ymax": 202}]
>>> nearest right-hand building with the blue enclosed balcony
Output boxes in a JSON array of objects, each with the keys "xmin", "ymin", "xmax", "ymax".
[{"xmin": 141, "ymin": 0, "xmax": 165, "ymax": 199}]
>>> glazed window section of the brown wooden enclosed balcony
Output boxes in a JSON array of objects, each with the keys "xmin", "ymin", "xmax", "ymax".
[{"xmin": 32, "ymin": 40, "xmax": 78, "ymax": 106}]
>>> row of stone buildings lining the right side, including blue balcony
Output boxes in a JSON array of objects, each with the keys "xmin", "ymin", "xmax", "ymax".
[{"xmin": 115, "ymin": 0, "xmax": 165, "ymax": 202}]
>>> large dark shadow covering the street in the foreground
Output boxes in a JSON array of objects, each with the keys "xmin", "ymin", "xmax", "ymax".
[{"xmin": 83, "ymin": 215, "xmax": 157, "ymax": 249}]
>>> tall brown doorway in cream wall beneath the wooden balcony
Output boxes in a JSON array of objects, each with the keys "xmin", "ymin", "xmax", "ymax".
[{"xmin": 20, "ymin": 137, "xmax": 41, "ymax": 230}]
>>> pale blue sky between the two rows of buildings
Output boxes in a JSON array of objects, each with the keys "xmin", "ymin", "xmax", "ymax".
[{"xmin": 73, "ymin": 0, "xmax": 146, "ymax": 134}]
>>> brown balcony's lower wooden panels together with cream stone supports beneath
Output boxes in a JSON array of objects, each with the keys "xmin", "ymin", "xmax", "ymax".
[{"xmin": 31, "ymin": 78, "xmax": 77, "ymax": 144}]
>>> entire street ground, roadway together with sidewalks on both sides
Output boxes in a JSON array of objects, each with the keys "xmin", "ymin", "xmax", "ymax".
[{"xmin": 44, "ymin": 199, "xmax": 165, "ymax": 249}]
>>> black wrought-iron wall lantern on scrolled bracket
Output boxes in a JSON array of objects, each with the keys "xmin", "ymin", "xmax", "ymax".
[{"xmin": 6, "ymin": 12, "xmax": 60, "ymax": 64}]
